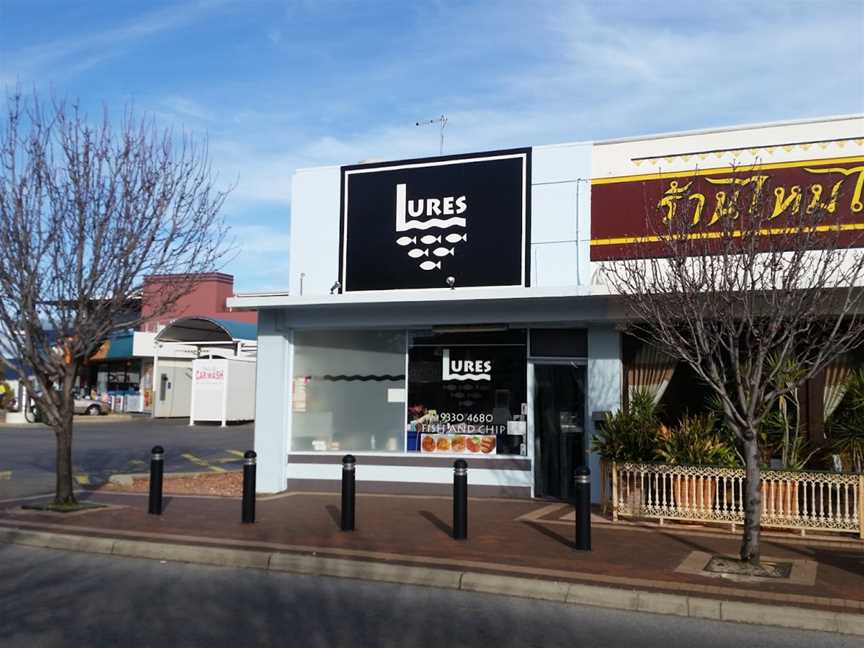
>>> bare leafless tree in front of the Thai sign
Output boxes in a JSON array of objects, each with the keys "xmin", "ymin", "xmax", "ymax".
[{"xmin": 602, "ymin": 165, "xmax": 864, "ymax": 563}]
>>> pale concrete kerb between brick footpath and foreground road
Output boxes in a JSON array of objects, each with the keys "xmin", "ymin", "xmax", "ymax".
[{"xmin": 0, "ymin": 528, "xmax": 864, "ymax": 636}]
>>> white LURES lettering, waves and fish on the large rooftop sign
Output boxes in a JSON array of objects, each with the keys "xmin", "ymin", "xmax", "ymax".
[{"xmin": 396, "ymin": 183, "xmax": 468, "ymax": 272}]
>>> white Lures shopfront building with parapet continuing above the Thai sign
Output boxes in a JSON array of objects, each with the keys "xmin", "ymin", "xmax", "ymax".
[{"xmin": 229, "ymin": 117, "xmax": 864, "ymax": 500}]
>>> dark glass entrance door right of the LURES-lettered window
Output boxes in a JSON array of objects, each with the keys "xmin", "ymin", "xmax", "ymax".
[{"xmin": 534, "ymin": 362, "xmax": 586, "ymax": 500}]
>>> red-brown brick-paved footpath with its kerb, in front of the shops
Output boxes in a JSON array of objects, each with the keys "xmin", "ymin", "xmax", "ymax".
[{"xmin": 0, "ymin": 493, "xmax": 864, "ymax": 636}]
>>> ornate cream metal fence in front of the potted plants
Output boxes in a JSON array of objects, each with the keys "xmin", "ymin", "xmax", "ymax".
[{"xmin": 604, "ymin": 462, "xmax": 864, "ymax": 539}]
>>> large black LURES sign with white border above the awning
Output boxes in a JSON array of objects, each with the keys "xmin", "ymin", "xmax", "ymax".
[{"xmin": 339, "ymin": 149, "xmax": 531, "ymax": 292}]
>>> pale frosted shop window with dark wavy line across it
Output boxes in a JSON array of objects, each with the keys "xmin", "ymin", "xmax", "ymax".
[{"xmin": 291, "ymin": 331, "xmax": 405, "ymax": 452}]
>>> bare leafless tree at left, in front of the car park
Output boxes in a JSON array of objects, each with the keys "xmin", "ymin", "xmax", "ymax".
[{"xmin": 0, "ymin": 93, "xmax": 227, "ymax": 505}]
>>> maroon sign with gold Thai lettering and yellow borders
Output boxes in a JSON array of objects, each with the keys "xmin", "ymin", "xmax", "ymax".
[{"xmin": 591, "ymin": 156, "xmax": 864, "ymax": 261}]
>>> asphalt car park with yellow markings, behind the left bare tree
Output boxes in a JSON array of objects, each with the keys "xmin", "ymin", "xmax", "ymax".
[{"xmin": 0, "ymin": 417, "xmax": 253, "ymax": 500}]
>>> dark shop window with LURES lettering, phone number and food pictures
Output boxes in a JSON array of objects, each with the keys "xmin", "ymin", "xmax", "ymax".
[{"xmin": 406, "ymin": 331, "xmax": 527, "ymax": 456}]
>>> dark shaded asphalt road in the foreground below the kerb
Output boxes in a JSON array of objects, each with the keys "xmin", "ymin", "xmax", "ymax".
[{"xmin": 0, "ymin": 545, "xmax": 861, "ymax": 648}]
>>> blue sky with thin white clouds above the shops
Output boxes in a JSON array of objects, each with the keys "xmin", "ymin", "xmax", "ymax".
[{"xmin": 0, "ymin": 0, "xmax": 864, "ymax": 291}]
